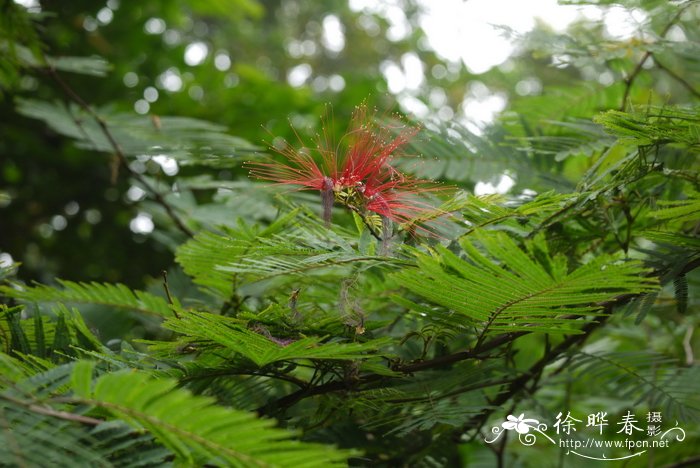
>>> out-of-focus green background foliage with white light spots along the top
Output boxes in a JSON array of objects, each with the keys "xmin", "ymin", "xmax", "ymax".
[{"xmin": 0, "ymin": 0, "xmax": 698, "ymax": 286}]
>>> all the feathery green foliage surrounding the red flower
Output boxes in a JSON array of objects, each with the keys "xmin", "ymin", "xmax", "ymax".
[{"xmin": 0, "ymin": 0, "xmax": 700, "ymax": 466}]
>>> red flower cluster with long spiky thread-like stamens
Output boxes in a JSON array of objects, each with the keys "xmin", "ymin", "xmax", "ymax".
[{"xmin": 248, "ymin": 105, "xmax": 441, "ymax": 234}]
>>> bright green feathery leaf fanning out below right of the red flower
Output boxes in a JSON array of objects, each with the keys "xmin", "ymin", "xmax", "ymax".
[{"xmin": 394, "ymin": 231, "xmax": 657, "ymax": 335}]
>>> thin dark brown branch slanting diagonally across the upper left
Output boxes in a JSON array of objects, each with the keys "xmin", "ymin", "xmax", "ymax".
[{"xmin": 45, "ymin": 65, "xmax": 194, "ymax": 237}]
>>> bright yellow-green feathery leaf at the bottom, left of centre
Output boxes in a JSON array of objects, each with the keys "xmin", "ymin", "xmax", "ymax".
[{"xmin": 76, "ymin": 371, "xmax": 351, "ymax": 467}]
